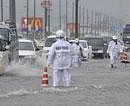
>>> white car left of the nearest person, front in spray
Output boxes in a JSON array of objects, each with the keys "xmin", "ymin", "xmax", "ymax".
[{"xmin": 17, "ymin": 38, "xmax": 37, "ymax": 64}]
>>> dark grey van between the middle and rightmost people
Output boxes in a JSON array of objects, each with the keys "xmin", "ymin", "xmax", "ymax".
[{"xmin": 84, "ymin": 37, "xmax": 106, "ymax": 58}]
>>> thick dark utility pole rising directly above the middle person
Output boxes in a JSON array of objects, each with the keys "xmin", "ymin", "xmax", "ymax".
[{"xmin": 75, "ymin": 0, "xmax": 79, "ymax": 38}]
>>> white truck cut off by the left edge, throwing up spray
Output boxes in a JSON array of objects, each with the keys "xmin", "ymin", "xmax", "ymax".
[{"xmin": 0, "ymin": 22, "xmax": 17, "ymax": 75}]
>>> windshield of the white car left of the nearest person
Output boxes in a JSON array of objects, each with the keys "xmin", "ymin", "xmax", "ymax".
[{"xmin": 19, "ymin": 42, "xmax": 34, "ymax": 51}]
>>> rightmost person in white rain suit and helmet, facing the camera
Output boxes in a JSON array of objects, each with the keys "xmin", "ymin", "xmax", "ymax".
[{"xmin": 107, "ymin": 36, "xmax": 123, "ymax": 68}]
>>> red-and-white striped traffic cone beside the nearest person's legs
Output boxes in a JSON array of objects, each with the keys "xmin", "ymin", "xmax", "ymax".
[{"xmin": 41, "ymin": 67, "xmax": 48, "ymax": 87}]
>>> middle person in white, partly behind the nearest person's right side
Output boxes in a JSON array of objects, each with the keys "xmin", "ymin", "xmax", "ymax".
[{"xmin": 72, "ymin": 39, "xmax": 83, "ymax": 67}]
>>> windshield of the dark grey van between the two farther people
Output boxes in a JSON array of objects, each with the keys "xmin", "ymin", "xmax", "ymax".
[{"xmin": 86, "ymin": 38, "xmax": 104, "ymax": 46}]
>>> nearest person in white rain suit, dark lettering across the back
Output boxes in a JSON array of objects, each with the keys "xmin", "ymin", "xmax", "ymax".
[{"xmin": 48, "ymin": 30, "xmax": 71, "ymax": 87}]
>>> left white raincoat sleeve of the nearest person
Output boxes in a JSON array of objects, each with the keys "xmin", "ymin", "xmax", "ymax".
[{"xmin": 48, "ymin": 44, "xmax": 55, "ymax": 65}]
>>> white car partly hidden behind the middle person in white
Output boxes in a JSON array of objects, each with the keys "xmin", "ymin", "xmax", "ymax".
[{"xmin": 69, "ymin": 40, "xmax": 92, "ymax": 60}]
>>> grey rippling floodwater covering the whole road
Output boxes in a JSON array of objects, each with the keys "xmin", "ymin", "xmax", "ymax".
[{"xmin": 0, "ymin": 56, "xmax": 130, "ymax": 106}]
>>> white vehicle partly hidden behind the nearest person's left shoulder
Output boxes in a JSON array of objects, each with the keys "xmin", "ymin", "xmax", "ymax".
[{"xmin": 43, "ymin": 35, "xmax": 56, "ymax": 57}]
